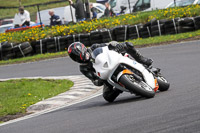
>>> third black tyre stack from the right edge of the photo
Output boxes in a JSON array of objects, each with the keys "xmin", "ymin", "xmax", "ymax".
[{"xmin": 164, "ymin": 18, "xmax": 180, "ymax": 35}]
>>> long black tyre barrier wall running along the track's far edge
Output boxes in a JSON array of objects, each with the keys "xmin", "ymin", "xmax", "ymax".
[{"xmin": 0, "ymin": 16, "xmax": 200, "ymax": 60}]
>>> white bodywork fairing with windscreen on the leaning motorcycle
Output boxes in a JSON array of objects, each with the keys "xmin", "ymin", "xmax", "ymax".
[{"xmin": 92, "ymin": 46, "xmax": 156, "ymax": 91}]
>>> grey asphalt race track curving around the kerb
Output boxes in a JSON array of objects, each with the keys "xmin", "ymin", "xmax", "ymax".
[{"xmin": 0, "ymin": 41, "xmax": 200, "ymax": 133}]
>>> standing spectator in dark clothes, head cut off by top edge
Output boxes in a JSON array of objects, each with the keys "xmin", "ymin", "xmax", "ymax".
[{"xmin": 69, "ymin": 0, "xmax": 85, "ymax": 22}]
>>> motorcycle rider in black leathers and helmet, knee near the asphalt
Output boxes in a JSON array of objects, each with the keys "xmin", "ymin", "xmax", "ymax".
[{"xmin": 68, "ymin": 41, "xmax": 153, "ymax": 102}]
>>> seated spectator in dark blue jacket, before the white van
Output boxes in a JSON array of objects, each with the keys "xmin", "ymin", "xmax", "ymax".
[{"xmin": 49, "ymin": 9, "xmax": 62, "ymax": 26}]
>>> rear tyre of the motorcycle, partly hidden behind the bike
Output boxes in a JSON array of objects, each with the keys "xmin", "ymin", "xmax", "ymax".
[{"xmin": 157, "ymin": 76, "xmax": 170, "ymax": 91}]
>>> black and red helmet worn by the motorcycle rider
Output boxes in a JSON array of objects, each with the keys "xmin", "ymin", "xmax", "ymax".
[{"xmin": 68, "ymin": 42, "xmax": 89, "ymax": 63}]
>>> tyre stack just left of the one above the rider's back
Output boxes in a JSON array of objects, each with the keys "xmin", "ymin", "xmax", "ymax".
[{"xmin": 99, "ymin": 28, "xmax": 113, "ymax": 43}]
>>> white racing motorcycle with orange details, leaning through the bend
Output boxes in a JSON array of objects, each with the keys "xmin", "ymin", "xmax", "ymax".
[{"xmin": 92, "ymin": 46, "xmax": 170, "ymax": 98}]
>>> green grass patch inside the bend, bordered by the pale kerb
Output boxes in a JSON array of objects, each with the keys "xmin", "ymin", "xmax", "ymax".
[{"xmin": 0, "ymin": 79, "xmax": 73, "ymax": 121}]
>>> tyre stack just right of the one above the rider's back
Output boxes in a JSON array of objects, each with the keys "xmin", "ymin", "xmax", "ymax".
[{"xmin": 127, "ymin": 25, "xmax": 140, "ymax": 39}]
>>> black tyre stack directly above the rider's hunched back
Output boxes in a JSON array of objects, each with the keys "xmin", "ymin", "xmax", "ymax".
[{"xmin": 114, "ymin": 25, "xmax": 128, "ymax": 42}]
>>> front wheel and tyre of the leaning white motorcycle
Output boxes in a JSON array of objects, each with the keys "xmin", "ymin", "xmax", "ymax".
[{"xmin": 119, "ymin": 75, "xmax": 155, "ymax": 98}]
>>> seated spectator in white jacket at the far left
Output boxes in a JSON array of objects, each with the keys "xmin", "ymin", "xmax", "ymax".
[{"xmin": 13, "ymin": 6, "xmax": 31, "ymax": 27}]
